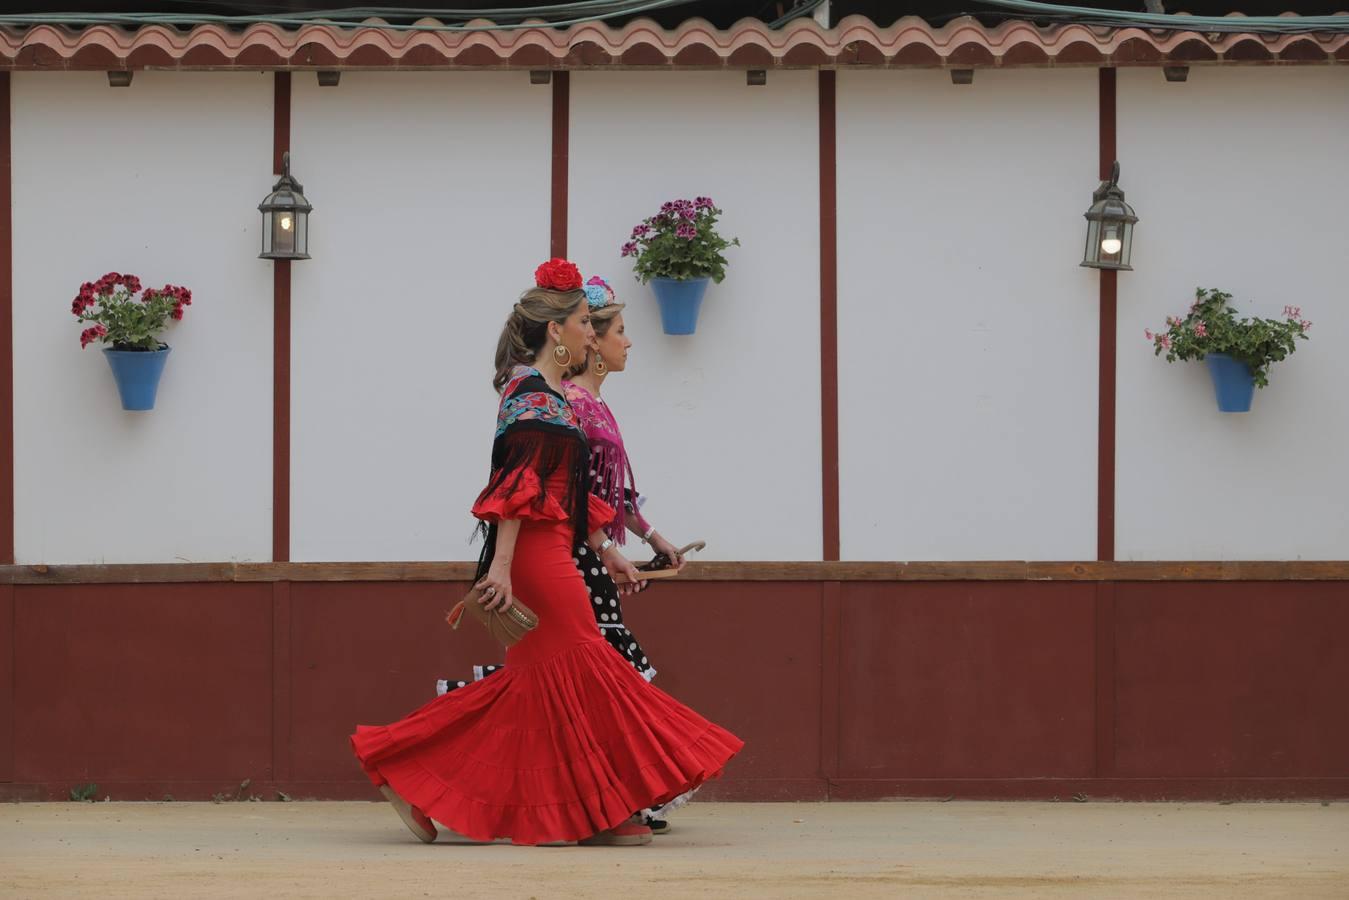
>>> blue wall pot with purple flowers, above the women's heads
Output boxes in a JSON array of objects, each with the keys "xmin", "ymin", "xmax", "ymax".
[{"xmin": 621, "ymin": 197, "xmax": 741, "ymax": 335}]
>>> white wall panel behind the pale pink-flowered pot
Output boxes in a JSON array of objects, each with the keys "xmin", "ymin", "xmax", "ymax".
[{"xmin": 1116, "ymin": 67, "xmax": 1349, "ymax": 560}]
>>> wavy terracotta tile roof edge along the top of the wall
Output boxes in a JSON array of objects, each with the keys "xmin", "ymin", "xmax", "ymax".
[{"xmin": 0, "ymin": 16, "xmax": 1349, "ymax": 69}]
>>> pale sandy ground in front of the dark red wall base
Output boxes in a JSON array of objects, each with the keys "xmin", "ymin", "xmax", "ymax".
[{"xmin": 0, "ymin": 801, "xmax": 1349, "ymax": 900}]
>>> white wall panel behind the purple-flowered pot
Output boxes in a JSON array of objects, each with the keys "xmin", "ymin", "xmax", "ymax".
[{"xmin": 568, "ymin": 72, "xmax": 822, "ymax": 560}]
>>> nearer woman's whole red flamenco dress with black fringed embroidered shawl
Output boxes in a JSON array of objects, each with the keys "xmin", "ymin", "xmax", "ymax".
[{"xmin": 351, "ymin": 367, "xmax": 745, "ymax": 843}]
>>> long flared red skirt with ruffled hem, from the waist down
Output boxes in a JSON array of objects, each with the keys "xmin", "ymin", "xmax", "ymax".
[{"xmin": 351, "ymin": 525, "xmax": 743, "ymax": 843}]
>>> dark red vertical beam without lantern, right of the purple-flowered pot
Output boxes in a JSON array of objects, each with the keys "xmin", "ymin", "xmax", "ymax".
[{"xmin": 819, "ymin": 69, "xmax": 839, "ymax": 560}]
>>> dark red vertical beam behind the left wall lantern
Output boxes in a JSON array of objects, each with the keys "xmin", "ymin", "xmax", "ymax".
[{"xmin": 271, "ymin": 72, "xmax": 290, "ymax": 563}]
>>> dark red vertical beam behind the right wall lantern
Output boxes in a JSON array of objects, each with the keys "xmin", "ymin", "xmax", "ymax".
[{"xmin": 1097, "ymin": 69, "xmax": 1118, "ymax": 561}]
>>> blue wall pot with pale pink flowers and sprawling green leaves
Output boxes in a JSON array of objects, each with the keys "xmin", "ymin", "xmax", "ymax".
[{"xmin": 1143, "ymin": 287, "xmax": 1311, "ymax": 413}]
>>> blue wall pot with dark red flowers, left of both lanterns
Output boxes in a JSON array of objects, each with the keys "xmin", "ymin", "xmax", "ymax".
[{"xmin": 70, "ymin": 273, "xmax": 192, "ymax": 410}]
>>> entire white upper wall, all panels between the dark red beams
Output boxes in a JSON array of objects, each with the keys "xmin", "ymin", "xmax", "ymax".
[{"xmin": 12, "ymin": 67, "xmax": 1349, "ymax": 563}]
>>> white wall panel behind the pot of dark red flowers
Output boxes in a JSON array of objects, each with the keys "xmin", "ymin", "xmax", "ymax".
[{"xmin": 12, "ymin": 72, "xmax": 272, "ymax": 563}]
